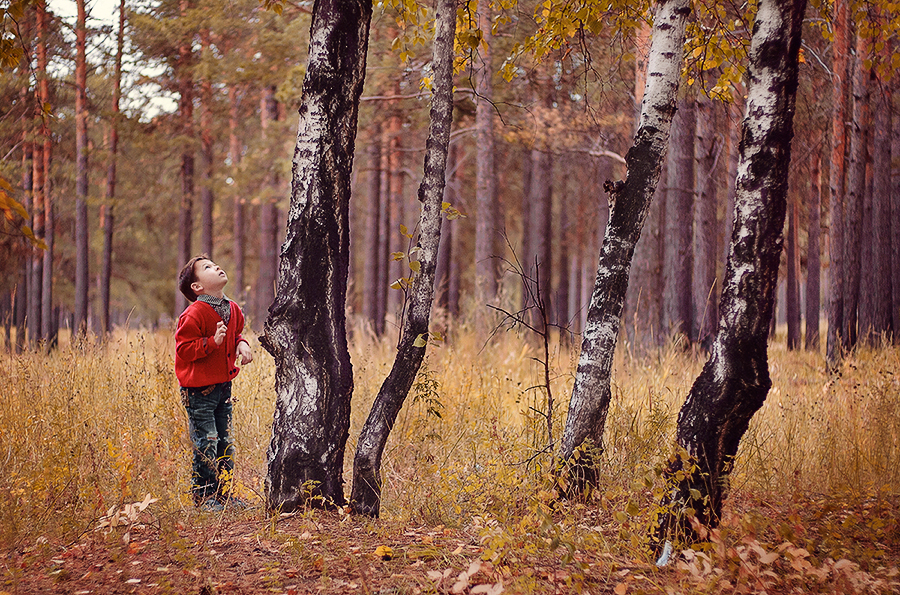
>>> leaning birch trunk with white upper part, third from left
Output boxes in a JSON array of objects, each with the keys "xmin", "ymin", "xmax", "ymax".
[{"xmin": 559, "ymin": 0, "xmax": 690, "ymax": 493}]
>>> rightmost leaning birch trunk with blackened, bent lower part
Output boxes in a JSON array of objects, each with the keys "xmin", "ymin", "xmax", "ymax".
[{"xmin": 657, "ymin": 0, "xmax": 806, "ymax": 542}]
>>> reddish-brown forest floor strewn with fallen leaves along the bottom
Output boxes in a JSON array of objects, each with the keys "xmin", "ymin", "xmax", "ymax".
[{"xmin": 0, "ymin": 488, "xmax": 900, "ymax": 595}]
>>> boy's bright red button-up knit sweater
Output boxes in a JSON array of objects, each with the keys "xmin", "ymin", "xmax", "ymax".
[{"xmin": 175, "ymin": 301, "xmax": 244, "ymax": 387}]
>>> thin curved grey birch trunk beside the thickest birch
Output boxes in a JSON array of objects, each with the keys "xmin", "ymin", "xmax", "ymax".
[{"xmin": 350, "ymin": 0, "xmax": 456, "ymax": 516}]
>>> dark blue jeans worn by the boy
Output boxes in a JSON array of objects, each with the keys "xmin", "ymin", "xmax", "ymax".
[{"xmin": 181, "ymin": 382, "xmax": 234, "ymax": 504}]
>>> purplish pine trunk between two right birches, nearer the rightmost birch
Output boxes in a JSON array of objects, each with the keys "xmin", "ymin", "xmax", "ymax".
[{"xmin": 691, "ymin": 99, "xmax": 722, "ymax": 352}]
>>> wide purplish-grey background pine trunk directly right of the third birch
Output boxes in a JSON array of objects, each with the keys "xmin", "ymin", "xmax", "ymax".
[{"xmin": 663, "ymin": 97, "xmax": 697, "ymax": 343}]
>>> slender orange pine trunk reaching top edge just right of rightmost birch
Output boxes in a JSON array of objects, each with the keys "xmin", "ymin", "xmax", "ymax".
[{"xmin": 825, "ymin": 0, "xmax": 848, "ymax": 370}]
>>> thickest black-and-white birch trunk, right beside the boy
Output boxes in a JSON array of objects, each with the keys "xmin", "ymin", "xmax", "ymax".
[{"xmin": 260, "ymin": 0, "xmax": 372, "ymax": 511}]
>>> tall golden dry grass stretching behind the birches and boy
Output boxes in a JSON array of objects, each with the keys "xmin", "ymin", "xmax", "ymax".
[{"xmin": 0, "ymin": 328, "xmax": 900, "ymax": 551}]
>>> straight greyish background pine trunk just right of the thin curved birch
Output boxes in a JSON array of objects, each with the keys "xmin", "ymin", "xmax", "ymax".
[{"xmin": 474, "ymin": 0, "xmax": 497, "ymax": 310}]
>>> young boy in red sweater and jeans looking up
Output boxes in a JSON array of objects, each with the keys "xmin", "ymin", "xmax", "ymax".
[{"xmin": 175, "ymin": 255, "xmax": 253, "ymax": 511}]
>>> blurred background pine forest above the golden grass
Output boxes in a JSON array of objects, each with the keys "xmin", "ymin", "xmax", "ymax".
[{"xmin": 0, "ymin": 0, "xmax": 900, "ymax": 361}]
